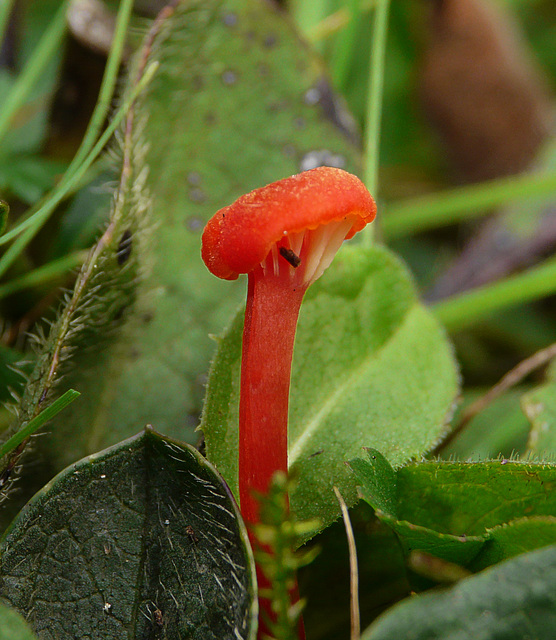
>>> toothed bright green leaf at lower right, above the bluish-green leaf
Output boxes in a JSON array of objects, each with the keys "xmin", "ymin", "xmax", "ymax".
[{"xmin": 350, "ymin": 450, "xmax": 556, "ymax": 570}]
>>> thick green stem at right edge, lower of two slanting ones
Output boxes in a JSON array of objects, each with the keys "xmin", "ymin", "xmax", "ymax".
[{"xmin": 433, "ymin": 258, "xmax": 556, "ymax": 332}]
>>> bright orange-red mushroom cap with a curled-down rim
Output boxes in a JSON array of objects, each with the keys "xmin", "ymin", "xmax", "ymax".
[{"xmin": 201, "ymin": 167, "xmax": 376, "ymax": 280}]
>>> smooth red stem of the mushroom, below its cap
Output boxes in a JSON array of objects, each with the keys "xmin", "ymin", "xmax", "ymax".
[{"xmin": 238, "ymin": 267, "xmax": 307, "ymax": 524}]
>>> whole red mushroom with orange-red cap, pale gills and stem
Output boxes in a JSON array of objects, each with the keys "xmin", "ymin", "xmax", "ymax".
[{"xmin": 202, "ymin": 167, "xmax": 376, "ymax": 636}]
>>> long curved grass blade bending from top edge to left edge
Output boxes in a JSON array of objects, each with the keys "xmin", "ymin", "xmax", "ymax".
[{"xmin": 0, "ymin": 0, "xmax": 133, "ymax": 246}]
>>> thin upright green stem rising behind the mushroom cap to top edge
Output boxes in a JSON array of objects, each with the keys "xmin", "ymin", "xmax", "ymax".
[{"xmin": 363, "ymin": 0, "xmax": 390, "ymax": 244}]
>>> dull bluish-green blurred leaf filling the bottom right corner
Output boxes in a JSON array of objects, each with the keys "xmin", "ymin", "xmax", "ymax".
[{"xmin": 361, "ymin": 546, "xmax": 556, "ymax": 640}]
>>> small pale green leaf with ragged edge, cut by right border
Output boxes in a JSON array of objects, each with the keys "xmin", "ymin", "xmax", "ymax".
[{"xmin": 522, "ymin": 364, "xmax": 556, "ymax": 457}]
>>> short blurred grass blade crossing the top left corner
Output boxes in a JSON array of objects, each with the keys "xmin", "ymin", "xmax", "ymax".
[{"xmin": 0, "ymin": 0, "xmax": 68, "ymax": 144}]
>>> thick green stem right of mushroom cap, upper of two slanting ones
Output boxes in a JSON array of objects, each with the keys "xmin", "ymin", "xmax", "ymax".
[{"xmin": 381, "ymin": 173, "xmax": 556, "ymax": 240}]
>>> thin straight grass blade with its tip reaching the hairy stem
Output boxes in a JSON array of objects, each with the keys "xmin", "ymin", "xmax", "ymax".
[{"xmin": 0, "ymin": 62, "xmax": 158, "ymax": 277}]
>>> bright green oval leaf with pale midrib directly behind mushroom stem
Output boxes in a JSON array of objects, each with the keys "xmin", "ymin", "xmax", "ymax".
[{"xmin": 202, "ymin": 247, "xmax": 458, "ymax": 536}]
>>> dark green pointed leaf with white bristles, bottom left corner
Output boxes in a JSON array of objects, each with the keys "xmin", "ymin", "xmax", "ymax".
[{"xmin": 0, "ymin": 431, "xmax": 257, "ymax": 640}]
